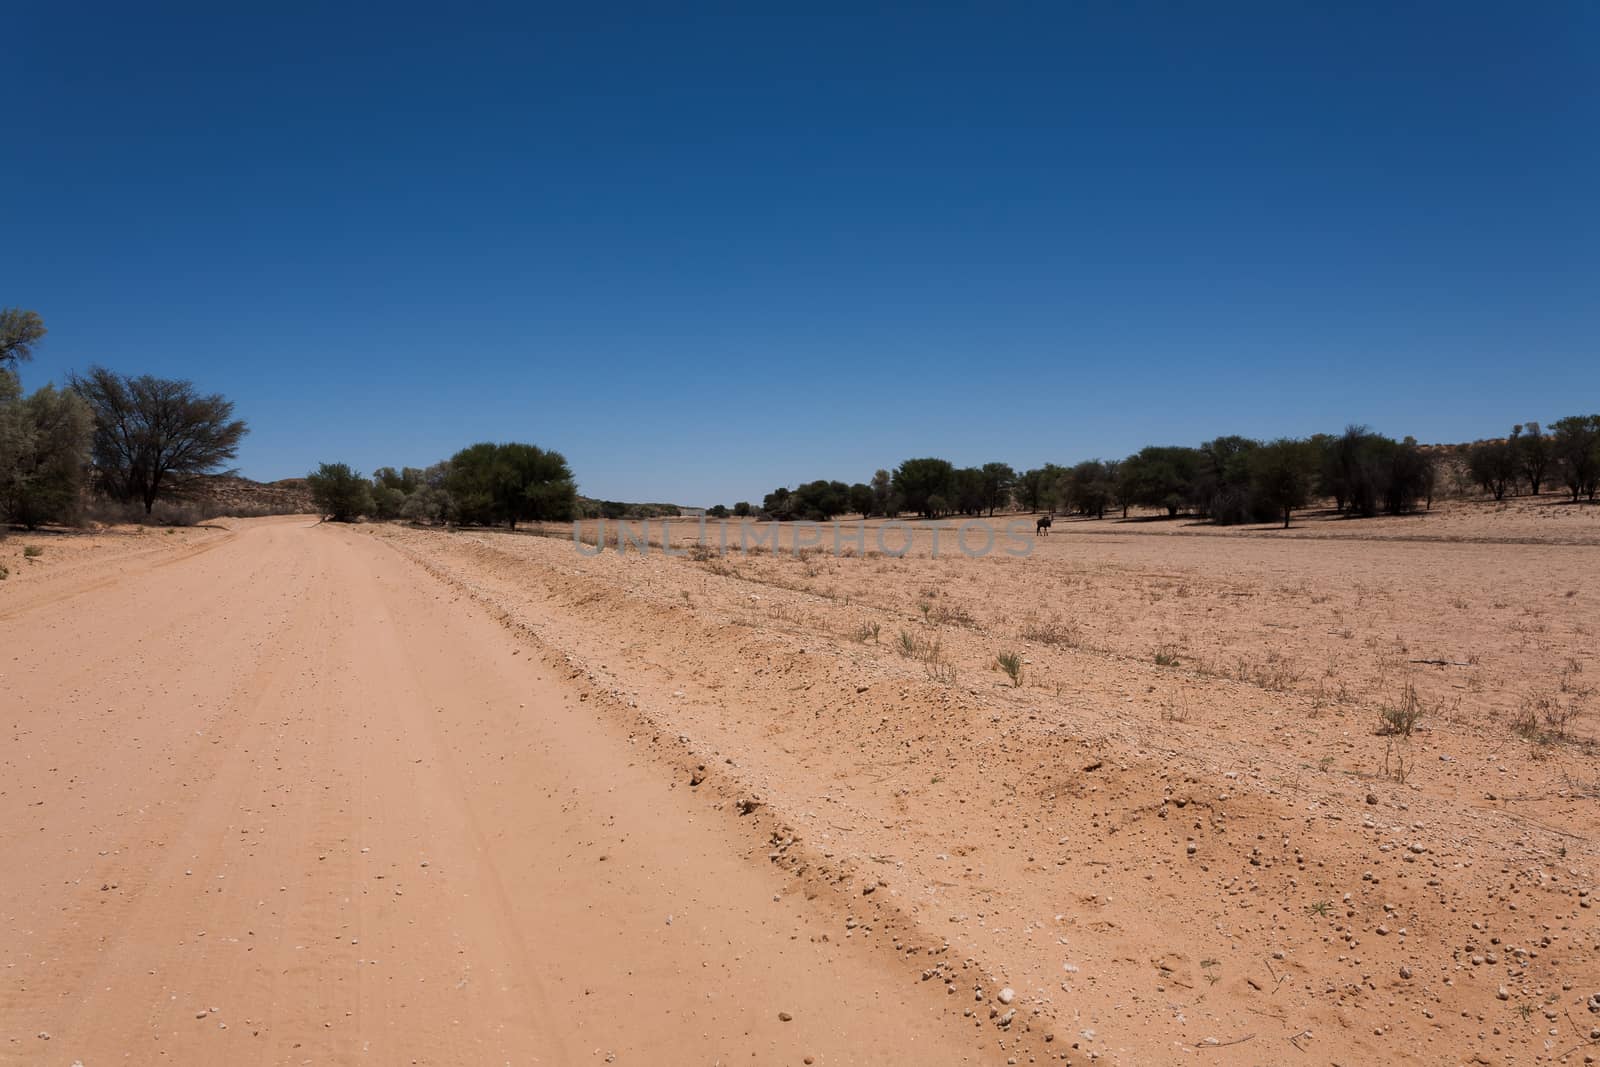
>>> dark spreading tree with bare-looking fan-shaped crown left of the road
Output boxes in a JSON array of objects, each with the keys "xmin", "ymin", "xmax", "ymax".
[{"xmin": 69, "ymin": 366, "xmax": 250, "ymax": 514}]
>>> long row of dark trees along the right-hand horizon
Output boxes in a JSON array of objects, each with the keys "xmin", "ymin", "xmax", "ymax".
[{"xmin": 739, "ymin": 416, "xmax": 1600, "ymax": 526}]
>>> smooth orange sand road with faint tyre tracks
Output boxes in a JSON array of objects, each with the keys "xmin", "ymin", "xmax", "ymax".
[{"xmin": 0, "ymin": 520, "xmax": 982, "ymax": 1067}]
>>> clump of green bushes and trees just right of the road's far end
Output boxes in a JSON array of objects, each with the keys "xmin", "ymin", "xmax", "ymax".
[{"xmin": 306, "ymin": 442, "xmax": 578, "ymax": 530}]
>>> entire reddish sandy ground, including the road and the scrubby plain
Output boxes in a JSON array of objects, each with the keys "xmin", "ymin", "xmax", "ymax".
[{"xmin": 0, "ymin": 498, "xmax": 1600, "ymax": 1067}]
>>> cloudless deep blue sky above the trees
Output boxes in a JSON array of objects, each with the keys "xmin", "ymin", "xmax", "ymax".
[{"xmin": 0, "ymin": 2, "xmax": 1600, "ymax": 504}]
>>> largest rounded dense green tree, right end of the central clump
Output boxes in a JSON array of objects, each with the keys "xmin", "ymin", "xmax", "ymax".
[{"xmin": 446, "ymin": 442, "xmax": 578, "ymax": 530}]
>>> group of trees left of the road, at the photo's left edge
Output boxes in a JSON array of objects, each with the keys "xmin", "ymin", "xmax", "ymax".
[{"xmin": 0, "ymin": 309, "xmax": 250, "ymax": 528}]
